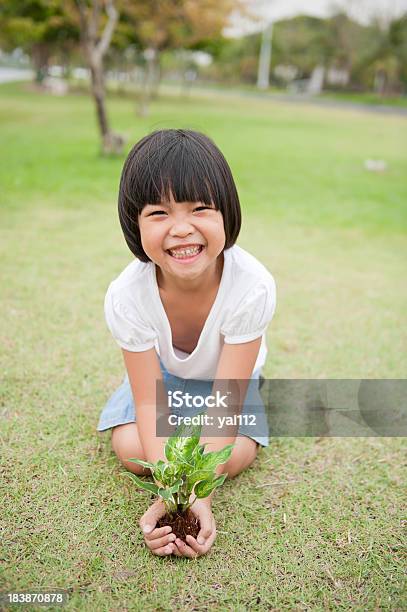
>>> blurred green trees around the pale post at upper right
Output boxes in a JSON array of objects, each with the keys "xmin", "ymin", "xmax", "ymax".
[{"xmin": 201, "ymin": 12, "xmax": 407, "ymax": 93}]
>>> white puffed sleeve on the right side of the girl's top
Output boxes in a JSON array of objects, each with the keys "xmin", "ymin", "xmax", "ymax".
[{"xmin": 220, "ymin": 277, "xmax": 276, "ymax": 344}]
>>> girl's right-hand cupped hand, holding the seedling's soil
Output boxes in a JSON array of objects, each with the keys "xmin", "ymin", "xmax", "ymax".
[{"xmin": 172, "ymin": 497, "xmax": 216, "ymax": 559}]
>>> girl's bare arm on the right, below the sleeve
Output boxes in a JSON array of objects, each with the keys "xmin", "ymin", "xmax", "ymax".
[{"xmin": 200, "ymin": 337, "xmax": 261, "ymax": 475}]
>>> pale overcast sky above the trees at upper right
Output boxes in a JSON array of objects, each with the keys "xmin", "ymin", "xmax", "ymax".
[{"xmin": 225, "ymin": 0, "xmax": 407, "ymax": 36}]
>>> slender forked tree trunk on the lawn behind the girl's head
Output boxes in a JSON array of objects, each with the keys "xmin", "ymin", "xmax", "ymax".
[{"xmin": 75, "ymin": 0, "xmax": 124, "ymax": 154}]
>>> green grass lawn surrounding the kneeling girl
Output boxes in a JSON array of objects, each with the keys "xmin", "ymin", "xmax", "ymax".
[{"xmin": 0, "ymin": 84, "xmax": 407, "ymax": 611}]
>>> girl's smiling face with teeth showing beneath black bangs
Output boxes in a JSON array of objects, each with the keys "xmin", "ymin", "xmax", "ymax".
[{"xmin": 138, "ymin": 196, "xmax": 226, "ymax": 280}]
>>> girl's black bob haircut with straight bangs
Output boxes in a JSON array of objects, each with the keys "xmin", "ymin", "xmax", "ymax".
[{"xmin": 118, "ymin": 129, "xmax": 241, "ymax": 262}]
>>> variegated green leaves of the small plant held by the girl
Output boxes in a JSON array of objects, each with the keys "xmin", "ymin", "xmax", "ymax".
[{"xmin": 126, "ymin": 418, "xmax": 234, "ymax": 514}]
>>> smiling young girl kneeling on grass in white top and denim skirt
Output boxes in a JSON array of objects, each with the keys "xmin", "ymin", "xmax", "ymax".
[{"xmin": 97, "ymin": 129, "xmax": 276, "ymax": 557}]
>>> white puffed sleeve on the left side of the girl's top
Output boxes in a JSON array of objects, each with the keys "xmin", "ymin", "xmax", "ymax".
[{"xmin": 104, "ymin": 286, "xmax": 157, "ymax": 352}]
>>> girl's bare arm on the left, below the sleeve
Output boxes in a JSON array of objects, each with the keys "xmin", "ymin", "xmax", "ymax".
[{"xmin": 122, "ymin": 348, "xmax": 172, "ymax": 463}]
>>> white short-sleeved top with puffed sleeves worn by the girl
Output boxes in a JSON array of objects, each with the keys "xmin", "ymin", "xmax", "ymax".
[{"xmin": 105, "ymin": 245, "xmax": 276, "ymax": 380}]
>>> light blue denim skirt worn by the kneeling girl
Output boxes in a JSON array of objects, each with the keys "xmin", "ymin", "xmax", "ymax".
[{"xmin": 97, "ymin": 360, "xmax": 269, "ymax": 446}]
